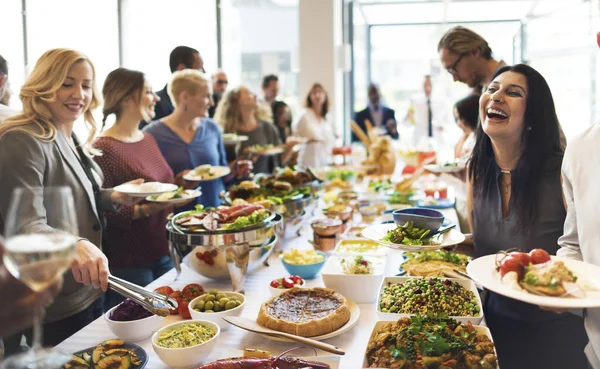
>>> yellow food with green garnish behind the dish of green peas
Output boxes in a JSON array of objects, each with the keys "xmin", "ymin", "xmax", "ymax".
[{"xmin": 400, "ymin": 250, "xmax": 471, "ymax": 277}]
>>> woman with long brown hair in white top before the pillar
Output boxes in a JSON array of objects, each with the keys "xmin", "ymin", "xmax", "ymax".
[{"xmin": 293, "ymin": 83, "xmax": 336, "ymax": 168}]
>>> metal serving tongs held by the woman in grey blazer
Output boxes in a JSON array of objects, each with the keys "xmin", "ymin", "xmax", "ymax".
[{"xmin": 108, "ymin": 275, "xmax": 178, "ymax": 316}]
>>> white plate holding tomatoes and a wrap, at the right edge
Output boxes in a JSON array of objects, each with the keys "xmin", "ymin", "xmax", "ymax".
[{"xmin": 467, "ymin": 255, "xmax": 600, "ymax": 309}]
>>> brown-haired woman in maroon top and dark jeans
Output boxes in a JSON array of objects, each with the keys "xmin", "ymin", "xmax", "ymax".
[{"xmin": 94, "ymin": 68, "xmax": 191, "ymax": 310}]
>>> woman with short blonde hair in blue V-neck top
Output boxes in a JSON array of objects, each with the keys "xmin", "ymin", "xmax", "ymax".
[{"xmin": 144, "ymin": 69, "xmax": 252, "ymax": 210}]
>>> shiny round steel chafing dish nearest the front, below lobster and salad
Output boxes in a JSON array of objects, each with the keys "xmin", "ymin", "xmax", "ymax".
[{"xmin": 167, "ymin": 213, "xmax": 283, "ymax": 292}]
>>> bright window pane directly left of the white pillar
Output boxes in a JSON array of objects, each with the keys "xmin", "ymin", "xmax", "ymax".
[{"xmin": 221, "ymin": 0, "xmax": 304, "ymax": 113}]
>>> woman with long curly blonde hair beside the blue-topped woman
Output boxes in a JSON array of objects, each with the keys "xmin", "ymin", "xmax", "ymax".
[{"xmin": 215, "ymin": 86, "xmax": 298, "ymax": 173}]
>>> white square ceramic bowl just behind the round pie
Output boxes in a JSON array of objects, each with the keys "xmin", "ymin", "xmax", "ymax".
[{"xmin": 321, "ymin": 255, "xmax": 386, "ymax": 304}]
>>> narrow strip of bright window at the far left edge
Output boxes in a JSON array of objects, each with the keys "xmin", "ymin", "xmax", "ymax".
[{"xmin": 0, "ymin": 0, "xmax": 25, "ymax": 109}]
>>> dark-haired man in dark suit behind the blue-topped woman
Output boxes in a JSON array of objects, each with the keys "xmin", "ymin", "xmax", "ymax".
[{"xmin": 154, "ymin": 46, "xmax": 205, "ymax": 123}]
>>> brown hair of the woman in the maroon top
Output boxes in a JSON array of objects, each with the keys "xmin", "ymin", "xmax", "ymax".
[{"xmin": 102, "ymin": 68, "xmax": 150, "ymax": 129}]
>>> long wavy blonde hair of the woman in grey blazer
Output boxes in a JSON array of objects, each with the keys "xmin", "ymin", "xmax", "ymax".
[{"xmin": 0, "ymin": 49, "xmax": 100, "ymax": 155}]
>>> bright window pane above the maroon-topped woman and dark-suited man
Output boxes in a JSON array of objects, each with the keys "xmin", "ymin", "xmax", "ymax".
[{"xmin": 120, "ymin": 0, "xmax": 217, "ymax": 90}]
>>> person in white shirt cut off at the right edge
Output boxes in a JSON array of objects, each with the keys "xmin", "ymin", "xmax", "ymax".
[{"xmin": 557, "ymin": 124, "xmax": 600, "ymax": 369}]
